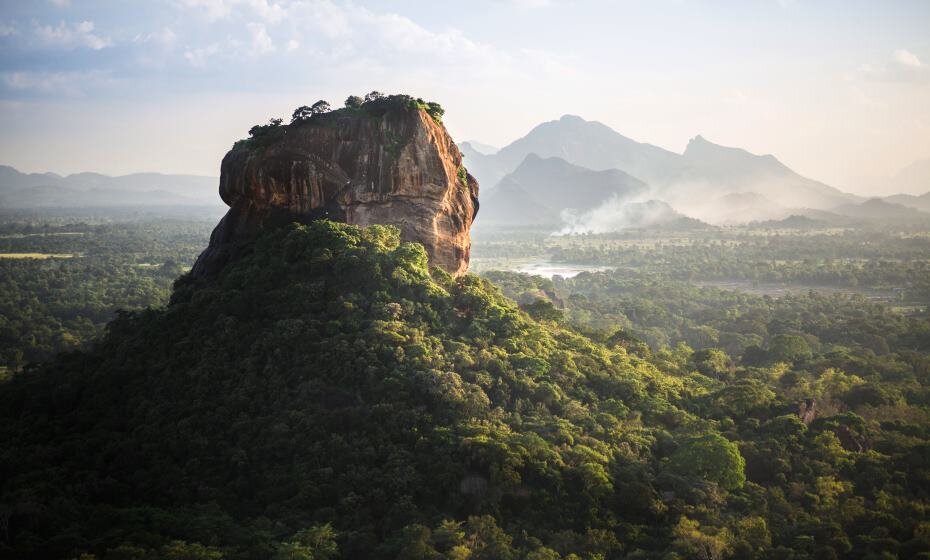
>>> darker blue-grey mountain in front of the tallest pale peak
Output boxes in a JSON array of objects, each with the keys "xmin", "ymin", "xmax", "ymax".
[{"xmin": 479, "ymin": 154, "xmax": 647, "ymax": 226}]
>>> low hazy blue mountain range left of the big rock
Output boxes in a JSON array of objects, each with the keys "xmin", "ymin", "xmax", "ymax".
[{"xmin": 0, "ymin": 166, "xmax": 223, "ymax": 208}]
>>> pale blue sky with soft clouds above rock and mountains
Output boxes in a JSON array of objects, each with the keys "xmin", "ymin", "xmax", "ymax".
[{"xmin": 0, "ymin": 0, "xmax": 930, "ymax": 194}]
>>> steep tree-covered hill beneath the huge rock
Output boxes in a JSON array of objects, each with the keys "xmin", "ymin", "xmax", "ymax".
[{"xmin": 0, "ymin": 220, "xmax": 732, "ymax": 560}]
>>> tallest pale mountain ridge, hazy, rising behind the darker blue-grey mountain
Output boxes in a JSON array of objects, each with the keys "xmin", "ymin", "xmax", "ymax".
[{"xmin": 464, "ymin": 115, "xmax": 863, "ymax": 228}]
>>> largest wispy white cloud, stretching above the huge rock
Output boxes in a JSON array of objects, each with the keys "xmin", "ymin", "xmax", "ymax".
[{"xmin": 167, "ymin": 0, "xmax": 560, "ymax": 81}]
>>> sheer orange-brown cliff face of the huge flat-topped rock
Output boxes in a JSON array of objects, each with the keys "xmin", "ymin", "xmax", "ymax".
[{"xmin": 192, "ymin": 108, "xmax": 478, "ymax": 276}]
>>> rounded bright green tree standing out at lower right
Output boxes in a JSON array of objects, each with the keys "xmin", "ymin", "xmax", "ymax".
[{"xmin": 669, "ymin": 434, "xmax": 746, "ymax": 490}]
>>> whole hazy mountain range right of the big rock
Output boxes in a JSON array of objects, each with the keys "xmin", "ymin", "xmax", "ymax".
[{"xmin": 460, "ymin": 115, "xmax": 930, "ymax": 231}]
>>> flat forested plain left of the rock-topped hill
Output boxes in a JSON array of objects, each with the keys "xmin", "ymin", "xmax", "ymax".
[{"xmin": 0, "ymin": 219, "xmax": 213, "ymax": 371}]
